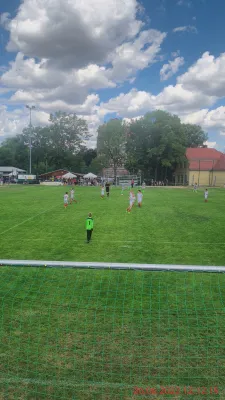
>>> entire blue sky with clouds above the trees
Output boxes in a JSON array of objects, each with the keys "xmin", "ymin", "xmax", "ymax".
[{"xmin": 0, "ymin": 0, "xmax": 225, "ymax": 150}]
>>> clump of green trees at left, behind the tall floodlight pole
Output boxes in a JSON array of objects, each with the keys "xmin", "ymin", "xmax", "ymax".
[{"xmin": 0, "ymin": 112, "xmax": 91, "ymax": 174}]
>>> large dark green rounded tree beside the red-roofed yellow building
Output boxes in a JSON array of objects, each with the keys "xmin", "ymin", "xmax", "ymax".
[{"xmin": 125, "ymin": 110, "xmax": 207, "ymax": 180}]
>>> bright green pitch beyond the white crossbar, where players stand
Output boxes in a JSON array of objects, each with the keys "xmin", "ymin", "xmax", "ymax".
[{"xmin": 0, "ymin": 185, "xmax": 225, "ymax": 265}]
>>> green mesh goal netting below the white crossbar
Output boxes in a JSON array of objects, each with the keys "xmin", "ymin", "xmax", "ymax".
[{"xmin": 0, "ymin": 267, "xmax": 225, "ymax": 400}]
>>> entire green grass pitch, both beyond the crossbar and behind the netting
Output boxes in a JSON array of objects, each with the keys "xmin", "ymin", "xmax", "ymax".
[{"xmin": 0, "ymin": 186, "xmax": 225, "ymax": 400}]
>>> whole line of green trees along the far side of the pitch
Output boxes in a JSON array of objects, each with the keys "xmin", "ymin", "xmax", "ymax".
[{"xmin": 0, "ymin": 110, "xmax": 207, "ymax": 180}]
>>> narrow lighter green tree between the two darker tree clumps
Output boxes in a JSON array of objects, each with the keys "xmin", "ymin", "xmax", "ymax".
[{"xmin": 97, "ymin": 119, "xmax": 127, "ymax": 177}]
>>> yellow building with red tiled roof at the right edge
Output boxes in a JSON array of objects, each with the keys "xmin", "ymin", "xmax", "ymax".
[{"xmin": 175, "ymin": 147, "xmax": 225, "ymax": 186}]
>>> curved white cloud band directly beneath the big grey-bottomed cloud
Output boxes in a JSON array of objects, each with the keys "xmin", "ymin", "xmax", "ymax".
[{"xmin": 0, "ymin": 26, "xmax": 166, "ymax": 103}]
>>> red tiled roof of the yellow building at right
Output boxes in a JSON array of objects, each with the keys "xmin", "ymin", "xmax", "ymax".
[{"xmin": 186, "ymin": 147, "xmax": 225, "ymax": 171}]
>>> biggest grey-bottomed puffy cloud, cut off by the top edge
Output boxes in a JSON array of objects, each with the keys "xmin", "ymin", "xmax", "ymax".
[{"xmin": 7, "ymin": 0, "xmax": 143, "ymax": 68}]
